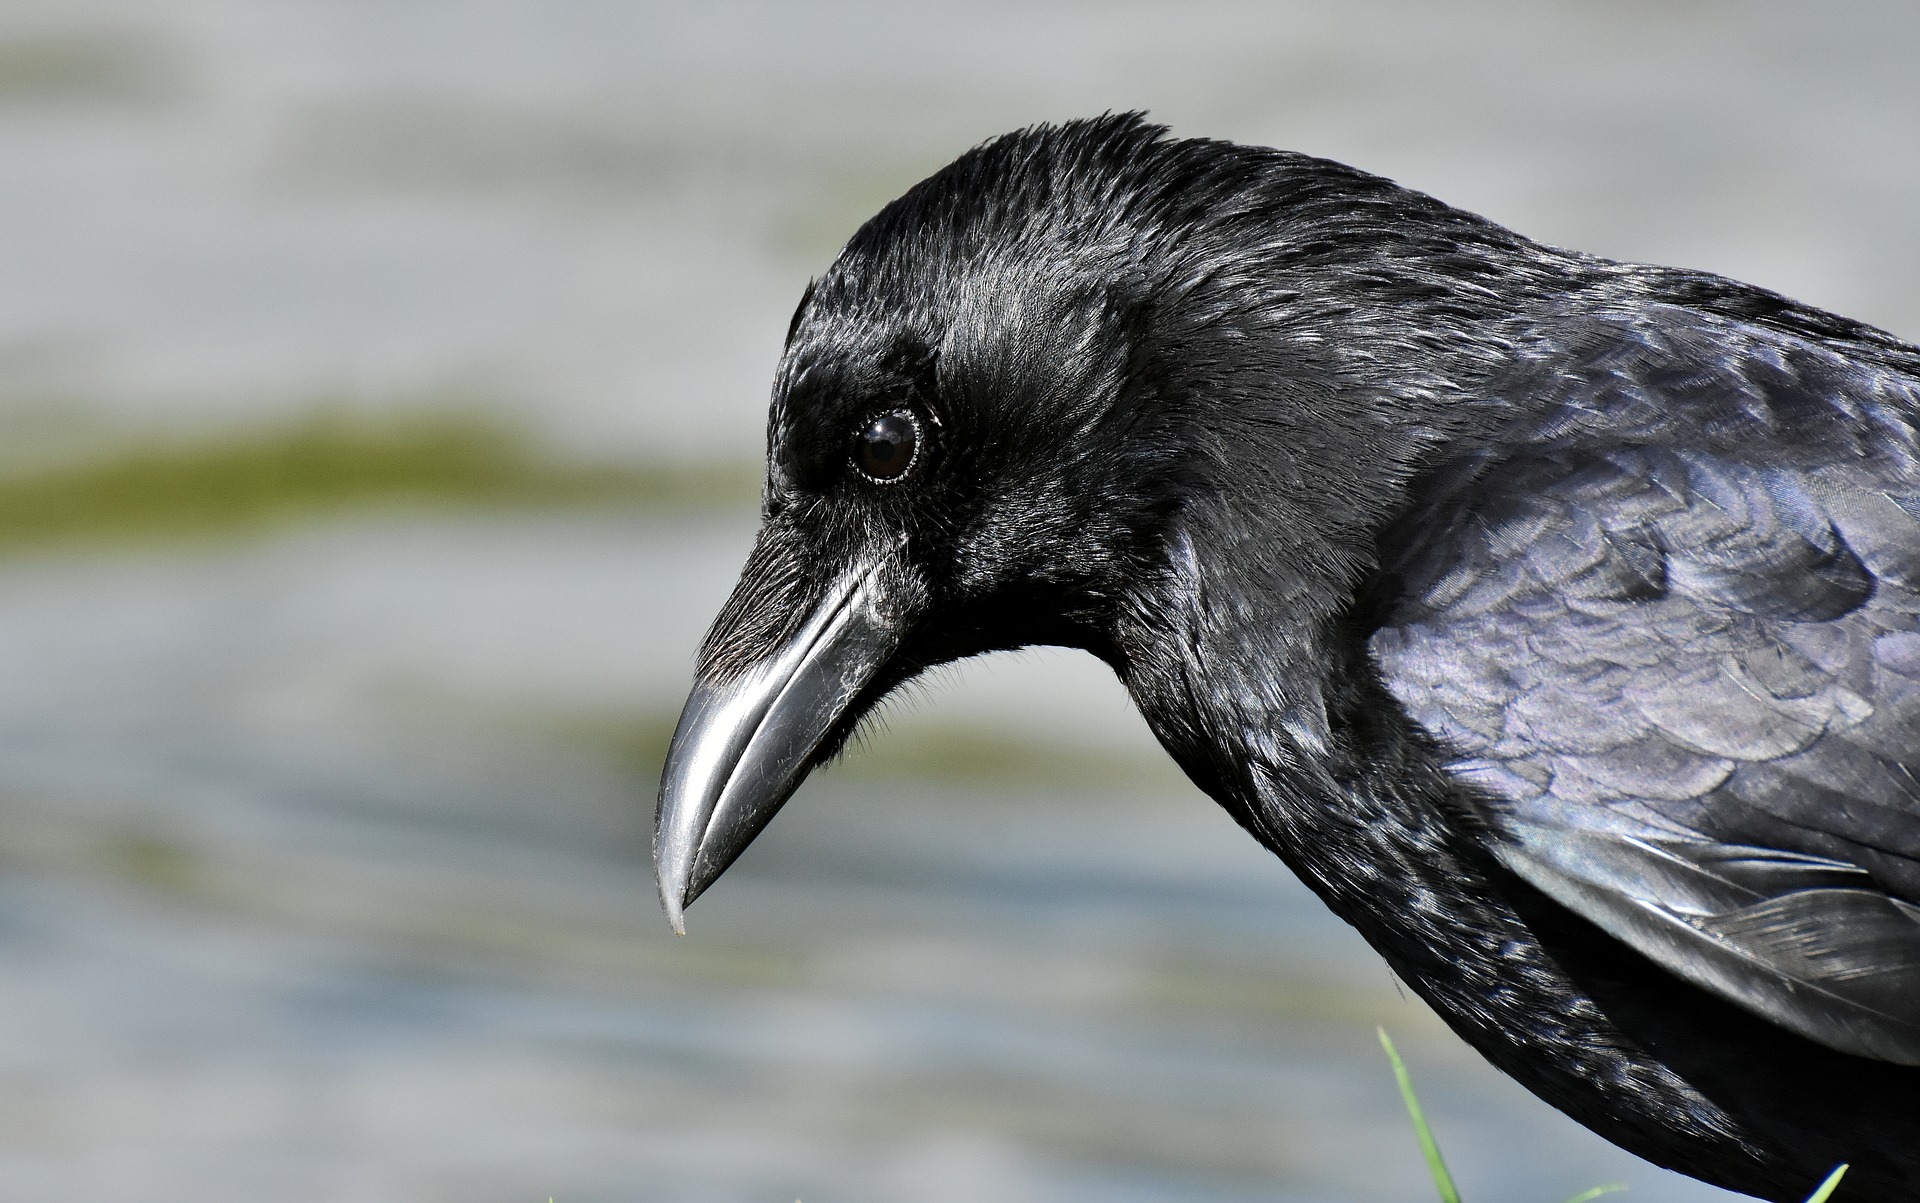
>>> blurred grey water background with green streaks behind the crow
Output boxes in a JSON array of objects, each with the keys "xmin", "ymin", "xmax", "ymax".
[{"xmin": 0, "ymin": 0, "xmax": 1920, "ymax": 1203}]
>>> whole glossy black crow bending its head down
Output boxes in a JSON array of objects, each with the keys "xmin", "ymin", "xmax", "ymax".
[{"xmin": 657, "ymin": 115, "xmax": 1920, "ymax": 1199}]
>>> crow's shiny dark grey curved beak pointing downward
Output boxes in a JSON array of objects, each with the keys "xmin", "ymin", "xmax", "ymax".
[{"xmin": 653, "ymin": 564, "xmax": 900, "ymax": 934}]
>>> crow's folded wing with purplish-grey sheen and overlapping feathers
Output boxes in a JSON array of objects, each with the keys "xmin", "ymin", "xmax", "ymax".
[{"xmin": 1369, "ymin": 307, "xmax": 1920, "ymax": 1065}]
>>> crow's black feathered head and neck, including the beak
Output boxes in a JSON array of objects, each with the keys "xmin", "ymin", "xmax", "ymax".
[{"xmin": 655, "ymin": 117, "xmax": 1567, "ymax": 929}]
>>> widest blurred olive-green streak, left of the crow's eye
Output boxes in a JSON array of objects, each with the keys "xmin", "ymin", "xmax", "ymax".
[{"xmin": 0, "ymin": 411, "xmax": 760, "ymax": 554}]
